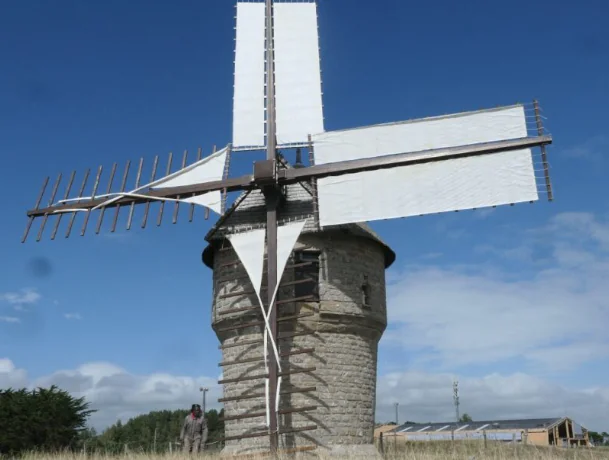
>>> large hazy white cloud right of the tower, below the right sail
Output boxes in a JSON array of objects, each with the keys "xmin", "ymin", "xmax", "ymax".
[{"xmin": 382, "ymin": 213, "xmax": 609, "ymax": 370}]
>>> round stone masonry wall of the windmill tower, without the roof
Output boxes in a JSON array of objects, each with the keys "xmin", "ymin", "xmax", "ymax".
[{"xmin": 212, "ymin": 232, "xmax": 387, "ymax": 452}]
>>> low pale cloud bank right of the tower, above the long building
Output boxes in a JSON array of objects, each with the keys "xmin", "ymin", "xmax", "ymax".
[{"xmin": 377, "ymin": 372, "xmax": 609, "ymax": 431}]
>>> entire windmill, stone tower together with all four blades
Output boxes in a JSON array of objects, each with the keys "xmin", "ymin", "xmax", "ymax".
[{"xmin": 23, "ymin": 0, "xmax": 552, "ymax": 452}]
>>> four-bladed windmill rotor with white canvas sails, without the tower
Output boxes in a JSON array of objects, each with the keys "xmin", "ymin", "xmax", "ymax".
[{"xmin": 23, "ymin": 0, "xmax": 552, "ymax": 452}]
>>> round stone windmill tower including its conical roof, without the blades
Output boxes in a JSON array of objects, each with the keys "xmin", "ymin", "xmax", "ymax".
[{"xmin": 203, "ymin": 156, "xmax": 395, "ymax": 455}]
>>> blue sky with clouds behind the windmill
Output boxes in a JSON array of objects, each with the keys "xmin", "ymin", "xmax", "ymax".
[{"xmin": 0, "ymin": 0, "xmax": 609, "ymax": 429}]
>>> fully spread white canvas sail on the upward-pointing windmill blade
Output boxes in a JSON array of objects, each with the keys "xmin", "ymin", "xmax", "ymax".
[{"xmin": 233, "ymin": 2, "xmax": 324, "ymax": 150}]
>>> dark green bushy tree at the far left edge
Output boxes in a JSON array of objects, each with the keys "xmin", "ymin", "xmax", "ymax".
[{"xmin": 0, "ymin": 386, "xmax": 95, "ymax": 454}]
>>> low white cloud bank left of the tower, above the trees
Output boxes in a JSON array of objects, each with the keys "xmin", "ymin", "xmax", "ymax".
[{"xmin": 0, "ymin": 359, "xmax": 221, "ymax": 429}]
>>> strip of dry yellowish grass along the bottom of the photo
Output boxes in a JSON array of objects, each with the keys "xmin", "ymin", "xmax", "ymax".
[{"xmin": 14, "ymin": 442, "xmax": 609, "ymax": 460}]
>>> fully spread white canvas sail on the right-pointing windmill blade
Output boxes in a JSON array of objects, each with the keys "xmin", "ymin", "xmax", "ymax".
[{"xmin": 313, "ymin": 105, "xmax": 538, "ymax": 226}]
